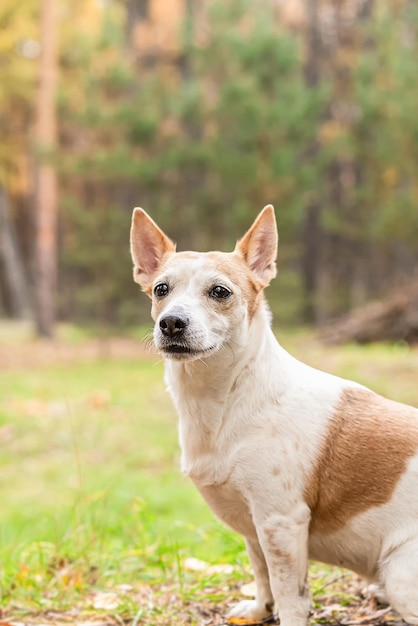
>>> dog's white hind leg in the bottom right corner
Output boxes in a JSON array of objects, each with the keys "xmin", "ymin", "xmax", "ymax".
[{"xmin": 380, "ymin": 538, "xmax": 418, "ymax": 625}]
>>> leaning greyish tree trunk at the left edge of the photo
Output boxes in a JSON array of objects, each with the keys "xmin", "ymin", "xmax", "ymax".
[{"xmin": 0, "ymin": 186, "xmax": 31, "ymax": 319}]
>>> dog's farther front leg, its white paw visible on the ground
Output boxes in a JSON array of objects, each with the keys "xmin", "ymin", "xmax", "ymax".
[{"xmin": 228, "ymin": 537, "xmax": 274, "ymax": 620}]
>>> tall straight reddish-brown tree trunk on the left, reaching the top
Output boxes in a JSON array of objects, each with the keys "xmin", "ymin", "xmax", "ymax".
[{"xmin": 35, "ymin": 0, "xmax": 57, "ymax": 337}]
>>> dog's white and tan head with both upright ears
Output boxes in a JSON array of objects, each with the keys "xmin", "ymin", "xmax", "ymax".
[{"xmin": 131, "ymin": 205, "xmax": 278, "ymax": 360}]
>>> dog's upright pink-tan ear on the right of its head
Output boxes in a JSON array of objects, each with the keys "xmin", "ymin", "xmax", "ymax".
[{"xmin": 235, "ymin": 204, "xmax": 278, "ymax": 287}]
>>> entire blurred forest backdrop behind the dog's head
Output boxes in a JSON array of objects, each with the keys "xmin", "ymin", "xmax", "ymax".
[{"xmin": 0, "ymin": 0, "xmax": 418, "ymax": 336}]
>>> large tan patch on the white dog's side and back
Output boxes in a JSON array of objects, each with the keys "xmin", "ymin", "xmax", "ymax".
[{"xmin": 305, "ymin": 388, "xmax": 418, "ymax": 533}]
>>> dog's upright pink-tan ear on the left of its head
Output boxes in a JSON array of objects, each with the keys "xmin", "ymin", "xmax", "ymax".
[{"xmin": 131, "ymin": 209, "xmax": 176, "ymax": 291}]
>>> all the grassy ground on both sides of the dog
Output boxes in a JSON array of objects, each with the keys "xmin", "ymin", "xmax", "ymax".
[{"xmin": 0, "ymin": 330, "xmax": 418, "ymax": 626}]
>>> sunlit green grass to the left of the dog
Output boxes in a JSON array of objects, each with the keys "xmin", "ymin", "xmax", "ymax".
[{"xmin": 0, "ymin": 342, "xmax": 248, "ymax": 620}]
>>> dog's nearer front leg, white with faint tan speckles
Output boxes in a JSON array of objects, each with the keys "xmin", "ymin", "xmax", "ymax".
[{"xmin": 254, "ymin": 503, "xmax": 310, "ymax": 626}]
